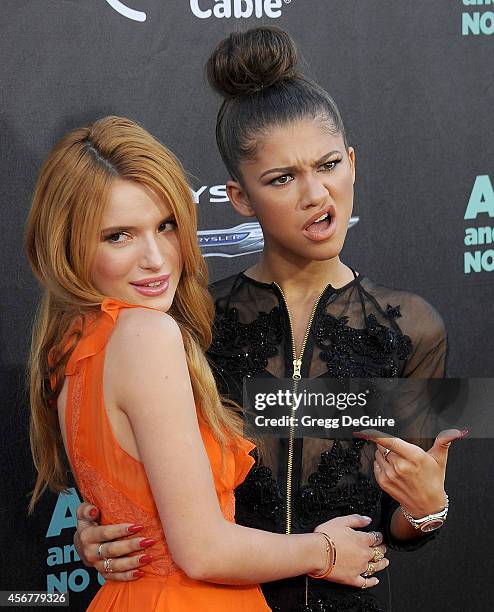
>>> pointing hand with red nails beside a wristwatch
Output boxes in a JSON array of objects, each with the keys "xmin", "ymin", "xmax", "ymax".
[{"xmin": 354, "ymin": 429, "xmax": 467, "ymax": 518}]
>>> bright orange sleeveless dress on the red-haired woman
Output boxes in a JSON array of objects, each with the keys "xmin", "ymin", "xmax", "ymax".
[{"xmin": 65, "ymin": 299, "xmax": 270, "ymax": 612}]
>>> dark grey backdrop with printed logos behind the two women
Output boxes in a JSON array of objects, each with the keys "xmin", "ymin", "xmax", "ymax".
[{"xmin": 0, "ymin": 0, "xmax": 494, "ymax": 611}]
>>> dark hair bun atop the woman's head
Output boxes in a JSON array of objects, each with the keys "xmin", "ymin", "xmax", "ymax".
[{"xmin": 206, "ymin": 26, "xmax": 299, "ymax": 98}]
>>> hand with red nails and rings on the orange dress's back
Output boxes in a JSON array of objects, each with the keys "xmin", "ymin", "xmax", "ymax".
[{"xmin": 74, "ymin": 502, "xmax": 152, "ymax": 582}]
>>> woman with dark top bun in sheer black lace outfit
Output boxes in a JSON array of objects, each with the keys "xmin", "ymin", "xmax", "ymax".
[{"xmin": 76, "ymin": 27, "xmax": 466, "ymax": 612}]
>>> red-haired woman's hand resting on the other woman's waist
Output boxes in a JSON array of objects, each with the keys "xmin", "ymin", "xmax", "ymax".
[{"xmin": 314, "ymin": 514, "xmax": 389, "ymax": 588}]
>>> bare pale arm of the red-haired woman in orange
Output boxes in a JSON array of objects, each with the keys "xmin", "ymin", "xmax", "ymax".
[{"xmin": 105, "ymin": 309, "xmax": 373, "ymax": 584}]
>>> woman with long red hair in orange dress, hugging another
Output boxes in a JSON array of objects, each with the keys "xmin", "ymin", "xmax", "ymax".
[{"xmin": 26, "ymin": 117, "xmax": 394, "ymax": 612}]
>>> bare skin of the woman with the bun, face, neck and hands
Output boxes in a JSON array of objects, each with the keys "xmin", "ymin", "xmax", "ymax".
[{"xmin": 75, "ymin": 120, "xmax": 464, "ymax": 586}]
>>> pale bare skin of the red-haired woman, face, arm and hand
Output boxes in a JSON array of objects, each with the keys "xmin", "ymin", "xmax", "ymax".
[{"xmin": 64, "ymin": 179, "xmax": 388, "ymax": 586}]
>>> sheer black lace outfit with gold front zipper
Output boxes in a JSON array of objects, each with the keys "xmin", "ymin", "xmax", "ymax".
[{"xmin": 208, "ymin": 273, "xmax": 447, "ymax": 612}]
